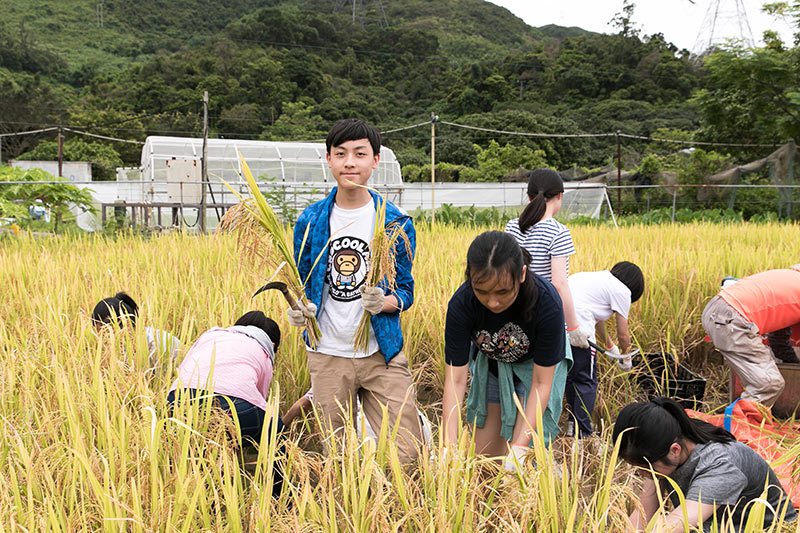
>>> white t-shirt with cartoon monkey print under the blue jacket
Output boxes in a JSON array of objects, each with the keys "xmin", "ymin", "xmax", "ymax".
[{"xmin": 317, "ymin": 198, "xmax": 378, "ymax": 358}]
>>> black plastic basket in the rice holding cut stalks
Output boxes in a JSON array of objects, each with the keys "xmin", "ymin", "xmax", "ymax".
[{"xmin": 633, "ymin": 353, "xmax": 706, "ymax": 407}]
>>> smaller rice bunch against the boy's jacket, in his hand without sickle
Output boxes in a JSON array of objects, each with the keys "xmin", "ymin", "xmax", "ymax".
[{"xmin": 351, "ymin": 187, "xmax": 413, "ymax": 352}]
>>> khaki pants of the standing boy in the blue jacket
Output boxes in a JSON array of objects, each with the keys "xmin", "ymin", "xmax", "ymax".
[{"xmin": 308, "ymin": 352, "xmax": 422, "ymax": 463}]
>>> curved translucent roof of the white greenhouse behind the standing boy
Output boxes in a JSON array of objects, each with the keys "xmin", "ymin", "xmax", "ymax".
[{"xmin": 142, "ymin": 136, "xmax": 402, "ymax": 185}]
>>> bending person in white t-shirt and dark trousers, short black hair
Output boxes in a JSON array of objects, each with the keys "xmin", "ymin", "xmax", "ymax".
[{"xmin": 565, "ymin": 261, "xmax": 644, "ymax": 438}]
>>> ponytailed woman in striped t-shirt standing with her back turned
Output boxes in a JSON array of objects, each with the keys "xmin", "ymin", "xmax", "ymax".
[{"xmin": 506, "ymin": 168, "xmax": 591, "ymax": 348}]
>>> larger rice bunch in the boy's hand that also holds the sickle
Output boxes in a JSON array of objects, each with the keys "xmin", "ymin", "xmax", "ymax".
[{"xmin": 217, "ymin": 152, "xmax": 322, "ymax": 349}]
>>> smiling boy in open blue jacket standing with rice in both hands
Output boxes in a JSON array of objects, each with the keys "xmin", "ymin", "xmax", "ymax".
[{"xmin": 286, "ymin": 119, "xmax": 421, "ymax": 462}]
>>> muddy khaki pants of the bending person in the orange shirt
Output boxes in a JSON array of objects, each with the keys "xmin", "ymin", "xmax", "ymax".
[{"xmin": 703, "ymin": 296, "xmax": 785, "ymax": 407}]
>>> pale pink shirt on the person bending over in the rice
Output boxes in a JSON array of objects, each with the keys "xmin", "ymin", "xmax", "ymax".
[{"xmin": 170, "ymin": 328, "xmax": 272, "ymax": 411}]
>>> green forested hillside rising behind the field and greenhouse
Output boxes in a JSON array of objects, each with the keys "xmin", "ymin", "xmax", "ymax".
[{"xmin": 0, "ymin": 0, "xmax": 800, "ymax": 183}]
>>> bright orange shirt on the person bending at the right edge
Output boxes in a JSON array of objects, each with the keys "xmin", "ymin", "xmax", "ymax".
[{"xmin": 719, "ymin": 268, "xmax": 800, "ymax": 335}]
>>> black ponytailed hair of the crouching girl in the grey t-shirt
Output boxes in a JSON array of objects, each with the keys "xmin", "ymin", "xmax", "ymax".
[{"xmin": 612, "ymin": 397, "xmax": 736, "ymax": 466}]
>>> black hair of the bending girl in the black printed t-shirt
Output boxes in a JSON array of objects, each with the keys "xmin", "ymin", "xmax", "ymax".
[{"xmin": 465, "ymin": 231, "xmax": 539, "ymax": 322}]
